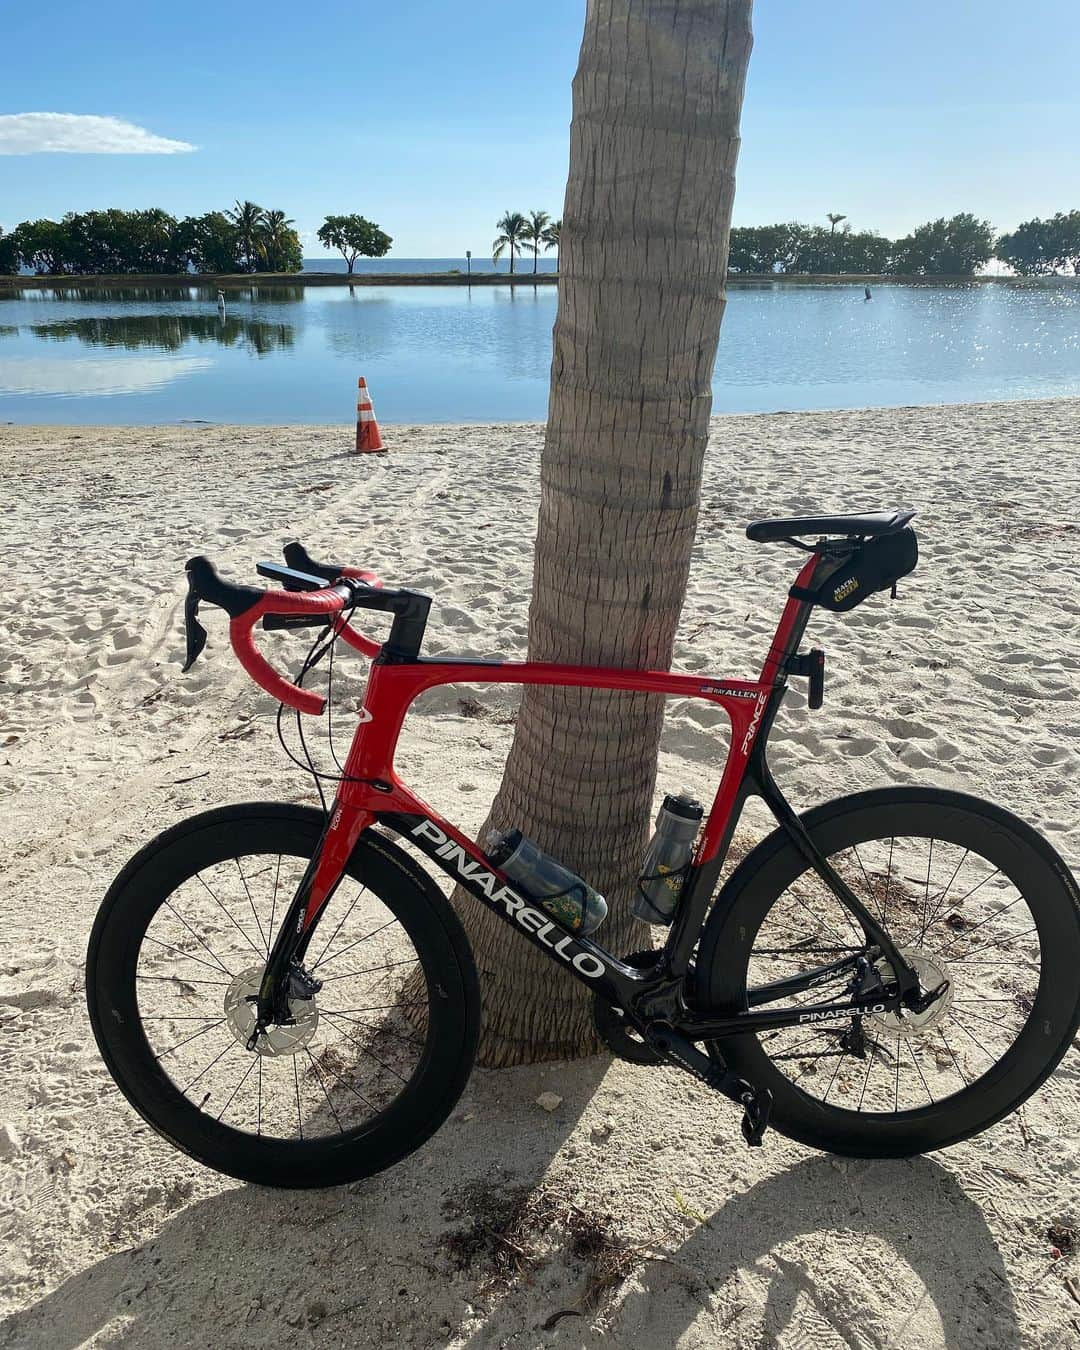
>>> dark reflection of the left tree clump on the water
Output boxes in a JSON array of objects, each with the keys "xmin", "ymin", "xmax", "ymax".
[{"xmin": 29, "ymin": 309, "xmax": 296, "ymax": 356}]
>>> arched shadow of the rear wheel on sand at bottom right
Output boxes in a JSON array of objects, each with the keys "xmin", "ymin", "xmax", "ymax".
[{"xmin": 620, "ymin": 1157, "xmax": 1023, "ymax": 1350}]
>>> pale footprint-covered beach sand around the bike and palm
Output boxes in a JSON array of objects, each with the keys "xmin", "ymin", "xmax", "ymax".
[{"xmin": 0, "ymin": 401, "xmax": 1080, "ymax": 1350}]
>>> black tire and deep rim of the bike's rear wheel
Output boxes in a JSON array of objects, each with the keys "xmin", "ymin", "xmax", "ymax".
[{"xmin": 697, "ymin": 787, "xmax": 1080, "ymax": 1157}]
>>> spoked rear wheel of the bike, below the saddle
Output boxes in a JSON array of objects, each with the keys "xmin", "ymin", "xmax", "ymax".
[{"xmin": 697, "ymin": 787, "xmax": 1080, "ymax": 1157}]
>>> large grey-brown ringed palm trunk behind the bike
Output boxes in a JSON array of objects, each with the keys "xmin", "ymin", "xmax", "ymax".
[{"xmin": 455, "ymin": 0, "xmax": 752, "ymax": 1065}]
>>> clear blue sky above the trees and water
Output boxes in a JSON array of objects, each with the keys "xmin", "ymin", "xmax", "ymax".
[{"xmin": 0, "ymin": 0, "xmax": 1080, "ymax": 258}]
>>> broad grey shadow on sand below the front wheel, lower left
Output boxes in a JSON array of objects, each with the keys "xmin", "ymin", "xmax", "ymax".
[{"xmin": 0, "ymin": 1057, "xmax": 610, "ymax": 1350}]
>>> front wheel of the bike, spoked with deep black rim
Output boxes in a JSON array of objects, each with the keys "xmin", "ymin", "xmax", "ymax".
[{"xmin": 86, "ymin": 803, "xmax": 479, "ymax": 1187}]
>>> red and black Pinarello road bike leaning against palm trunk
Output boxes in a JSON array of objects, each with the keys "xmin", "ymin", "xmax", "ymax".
[{"xmin": 86, "ymin": 512, "xmax": 1080, "ymax": 1187}]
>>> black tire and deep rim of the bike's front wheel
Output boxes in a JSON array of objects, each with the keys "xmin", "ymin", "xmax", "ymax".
[{"xmin": 86, "ymin": 803, "xmax": 481, "ymax": 1188}]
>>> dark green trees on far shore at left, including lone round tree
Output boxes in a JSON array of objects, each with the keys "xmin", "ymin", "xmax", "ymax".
[{"xmin": 0, "ymin": 201, "xmax": 392, "ymax": 277}]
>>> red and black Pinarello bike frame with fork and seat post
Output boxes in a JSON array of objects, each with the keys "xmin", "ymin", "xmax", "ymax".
[{"xmin": 259, "ymin": 552, "xmax": 918, "ymax": 1041}]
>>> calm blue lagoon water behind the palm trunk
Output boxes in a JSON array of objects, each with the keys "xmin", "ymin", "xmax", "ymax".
[{"xmin": 0, "ymin": 276, "xmax": 1080, "ymax": 424}]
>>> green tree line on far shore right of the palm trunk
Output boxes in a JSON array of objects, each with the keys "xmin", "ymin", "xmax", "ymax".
[{"xmin": 728, "ymin": 211, "xmax": 1080, "ymax": 277}]
